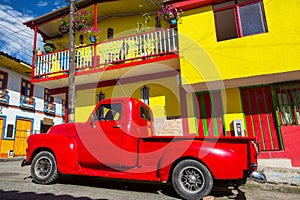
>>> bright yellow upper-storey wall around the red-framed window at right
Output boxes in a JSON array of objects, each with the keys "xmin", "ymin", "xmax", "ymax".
[{"xmin": 178, "ymin": 0, "xmax": 300, "ymax": 84}]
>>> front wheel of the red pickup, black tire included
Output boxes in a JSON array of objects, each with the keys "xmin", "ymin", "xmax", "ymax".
[{"xmin": 31, "ymin": 151, "xmax": 59, "ymax": 185}]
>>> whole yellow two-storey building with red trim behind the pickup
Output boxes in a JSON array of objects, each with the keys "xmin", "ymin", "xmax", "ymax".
[{"xmin": 24, "ymin": 0, "xmax": 300, "ymax": 167}]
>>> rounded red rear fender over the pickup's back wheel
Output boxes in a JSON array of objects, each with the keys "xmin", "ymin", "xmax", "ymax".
[{"xmin": 158, "ymin": 141, "xmax": 244, "ymax": 181}]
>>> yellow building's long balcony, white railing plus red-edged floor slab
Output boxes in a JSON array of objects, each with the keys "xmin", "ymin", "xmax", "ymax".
[{"xmin": 32, "ymin": 28, "xmax": 179, "ymax": 89}]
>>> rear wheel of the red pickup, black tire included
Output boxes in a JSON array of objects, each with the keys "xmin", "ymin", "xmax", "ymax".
[{"xmin": 172, "ymin": 160, "xmax": 213, "ymax": 200}]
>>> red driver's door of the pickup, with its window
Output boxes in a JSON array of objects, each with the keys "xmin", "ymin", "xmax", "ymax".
[{"xmin": 79, "ymin": 103, "xmax": 122, "ymax": 167}]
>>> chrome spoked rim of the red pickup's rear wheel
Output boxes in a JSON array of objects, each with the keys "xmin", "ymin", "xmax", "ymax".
[{"xmin": 179, "ymin": 166, "xmax": 205, "ymax": 193}]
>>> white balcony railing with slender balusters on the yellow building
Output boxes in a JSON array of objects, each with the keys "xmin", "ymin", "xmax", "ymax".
[{"xmin": 33, "ymin": 29, "xmax": 178, "ymax": 78}]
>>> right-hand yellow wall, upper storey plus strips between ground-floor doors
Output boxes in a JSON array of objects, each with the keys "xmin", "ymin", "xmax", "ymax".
[{"xmin": 178, "ymin": 0, "xmax": 300, "ymax": 134}]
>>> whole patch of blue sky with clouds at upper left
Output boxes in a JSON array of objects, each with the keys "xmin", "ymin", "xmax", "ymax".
[{"xmin": 0, "ymin": 0, "xmax": 69, "ymax": 64}]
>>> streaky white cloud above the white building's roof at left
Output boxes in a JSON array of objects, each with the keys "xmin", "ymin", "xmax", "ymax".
[{"xmin": 0, "ymin": 4, "xmax": 42, "ymax": 63}]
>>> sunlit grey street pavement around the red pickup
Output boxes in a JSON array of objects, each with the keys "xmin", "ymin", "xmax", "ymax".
[{"xmin": 0, "ymin": 160, "xmax": 300, "ymax": 200}]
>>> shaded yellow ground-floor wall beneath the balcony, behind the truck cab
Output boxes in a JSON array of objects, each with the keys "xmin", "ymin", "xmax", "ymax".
[{"xmin": 75, "ymin": 77, "xmax": 181, "ymax": 122}]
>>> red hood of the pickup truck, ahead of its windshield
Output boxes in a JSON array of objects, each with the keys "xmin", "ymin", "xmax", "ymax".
[{"xmin": 47, "ymin": 123, "xmax": 83, "ymax": 138}]
